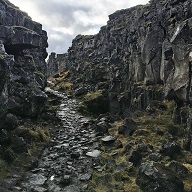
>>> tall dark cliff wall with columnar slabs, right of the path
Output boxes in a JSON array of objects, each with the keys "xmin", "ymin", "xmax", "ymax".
[{"xmin": 48, "ymin": 0, "xmax": 192, "ymax": 148}]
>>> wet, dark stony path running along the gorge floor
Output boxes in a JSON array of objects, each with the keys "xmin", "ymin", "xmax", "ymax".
[{"xmin": 18, "ymin": 89, "xmax": 97, "ymax": 192}]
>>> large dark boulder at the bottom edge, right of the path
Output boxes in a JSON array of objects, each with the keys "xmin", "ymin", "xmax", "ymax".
[{"xmin": 136, "ymin": 162, "xmax": 184, "ymax": 192}]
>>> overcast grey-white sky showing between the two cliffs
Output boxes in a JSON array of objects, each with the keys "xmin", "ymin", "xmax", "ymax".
[{"xmin": 9, "ymin": 0, "xmax": 148, "ymax": 53}]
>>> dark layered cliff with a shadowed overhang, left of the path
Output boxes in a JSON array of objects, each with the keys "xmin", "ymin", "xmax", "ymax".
[{"xmin": 0, "ymin": 0, "xmax": 48, "ymax": 129}]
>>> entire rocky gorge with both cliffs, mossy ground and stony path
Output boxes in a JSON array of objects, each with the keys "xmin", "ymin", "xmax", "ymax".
[{"xmin": 0, "ymin": 0, "xmax": 192, "ymax": 192}]
